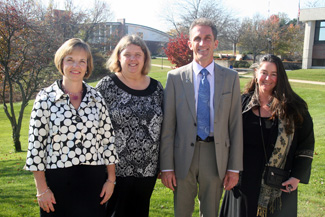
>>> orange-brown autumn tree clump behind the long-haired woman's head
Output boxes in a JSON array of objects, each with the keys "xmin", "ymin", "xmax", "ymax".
[{"xmin": 240, "ymin": 13, "xmax": 304, "ymax": 61}]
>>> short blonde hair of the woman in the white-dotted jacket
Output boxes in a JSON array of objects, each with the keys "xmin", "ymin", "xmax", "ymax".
[{"xmin": 54, "ymin": 38, "xmax": 94, "ymax": 78}]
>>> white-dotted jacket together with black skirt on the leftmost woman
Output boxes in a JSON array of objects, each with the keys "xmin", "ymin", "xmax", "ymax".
[{"xmin": 25, "ymin": 81, "xmax": 118, "ymax": 217}]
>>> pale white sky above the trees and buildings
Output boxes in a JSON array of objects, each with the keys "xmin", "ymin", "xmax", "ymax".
[{"xmin": 44, "ymin": 0, "xmax": 310, "ymax": 32}]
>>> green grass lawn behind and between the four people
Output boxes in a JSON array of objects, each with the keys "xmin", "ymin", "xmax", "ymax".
[{"xmin": 0, "ymin": 67, "xmax": 325, "ymax": 217}]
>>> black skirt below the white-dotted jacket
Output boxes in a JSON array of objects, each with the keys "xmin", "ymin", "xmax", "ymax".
[{"xmin": 40, "ymin": 165, "xmax": 107, "ymax": 217}]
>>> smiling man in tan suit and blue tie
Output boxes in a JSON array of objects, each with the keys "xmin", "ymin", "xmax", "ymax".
[{"xmin": 160, "ymin": 18, "xmax": 243, "ymax": 217}]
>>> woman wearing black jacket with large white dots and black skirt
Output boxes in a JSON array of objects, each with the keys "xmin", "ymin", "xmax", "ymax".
[{"xmin": 26, "ymin": 38, "xmax": 118, "ymax": 217}]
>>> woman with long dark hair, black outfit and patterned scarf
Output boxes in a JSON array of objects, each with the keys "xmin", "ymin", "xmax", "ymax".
[{"xmin": 220, "ymin": 55, "xmax": 315, "ymax": 217}]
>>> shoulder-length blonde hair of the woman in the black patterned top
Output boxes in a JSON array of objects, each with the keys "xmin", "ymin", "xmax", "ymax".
[{"xmin": 106, "ymin": 35, "xmax": 151, "ymax": 75}]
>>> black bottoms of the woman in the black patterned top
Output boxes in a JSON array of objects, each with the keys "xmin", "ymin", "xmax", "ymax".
[{"xmin": 106, "ymin": 177, "xmax": 157, "ymax": 217}]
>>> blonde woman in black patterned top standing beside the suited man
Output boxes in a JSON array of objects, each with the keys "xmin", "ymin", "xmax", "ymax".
[{"xmin": 96, "ymin": 35, "xmax": 163, "ymax": 217}]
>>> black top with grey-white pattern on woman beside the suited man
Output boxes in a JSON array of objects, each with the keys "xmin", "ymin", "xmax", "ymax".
[{"xmin": 96, "ymin": 74, "xmax": 163, "ymax": 177}]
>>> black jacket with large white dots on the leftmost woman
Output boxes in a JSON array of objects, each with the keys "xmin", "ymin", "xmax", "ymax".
[{"xmin": 25, "ymin": 81, "xmax": 118, "ymax": 171}]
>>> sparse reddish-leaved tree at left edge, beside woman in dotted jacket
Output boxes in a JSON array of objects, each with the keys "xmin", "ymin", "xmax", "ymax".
[{"xmin": 0, "ymin": 0, "xmax": 58, "ymax": 151}]
